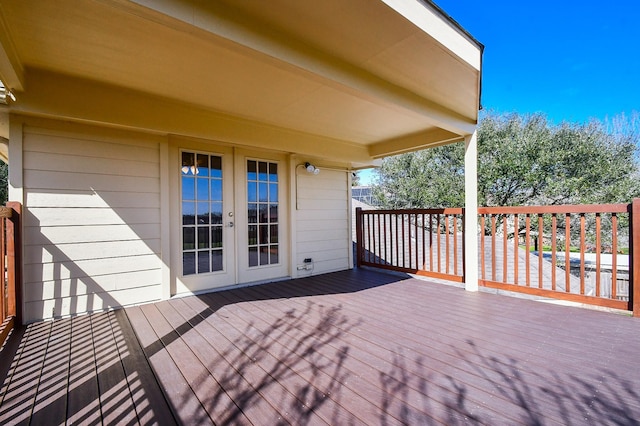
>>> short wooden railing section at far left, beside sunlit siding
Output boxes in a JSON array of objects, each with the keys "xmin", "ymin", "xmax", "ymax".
[{"xmin": 0, "ymin": 202, "xmax": 22, "ymax": 346}]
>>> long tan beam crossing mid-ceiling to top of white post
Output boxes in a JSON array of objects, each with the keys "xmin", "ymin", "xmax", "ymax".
[{"xmin": 115, "ymin": 0, "xmax": 475, "ymax": 134}]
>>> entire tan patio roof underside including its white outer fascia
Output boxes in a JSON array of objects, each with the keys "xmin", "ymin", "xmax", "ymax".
[{"xmin": 0, "ymin": 0, "xmax": 482, "ymax": 167}]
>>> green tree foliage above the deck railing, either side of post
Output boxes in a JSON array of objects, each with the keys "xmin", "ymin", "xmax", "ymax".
[{"xmin": 374, "ymin": 113, "xmax": 640, "ymax": 208}]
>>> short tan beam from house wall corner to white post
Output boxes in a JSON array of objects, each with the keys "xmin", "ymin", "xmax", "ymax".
[{"xmin": 369, "ymin": 128, "xmax": 464, "ymax": 158}]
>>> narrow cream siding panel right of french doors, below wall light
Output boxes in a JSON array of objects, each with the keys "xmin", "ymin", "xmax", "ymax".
[{"xmin": 295, "ymin": 168, "xmax": 351, "ymax": 276}]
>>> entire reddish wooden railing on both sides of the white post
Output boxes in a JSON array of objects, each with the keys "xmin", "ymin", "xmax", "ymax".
[{"xmin": 356, "ymin": 200, "xmax": 640, "ymax": 316}]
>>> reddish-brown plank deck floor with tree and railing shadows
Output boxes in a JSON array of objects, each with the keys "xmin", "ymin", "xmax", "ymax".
[{"xmin": 0, "ymin": 269, "xmax": 640, "ymax": 425}]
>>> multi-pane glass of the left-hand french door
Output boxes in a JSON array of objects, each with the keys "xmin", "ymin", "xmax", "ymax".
[{"xmin": 180, "ymin": 151, "xmax": 224, "ymax": 275}]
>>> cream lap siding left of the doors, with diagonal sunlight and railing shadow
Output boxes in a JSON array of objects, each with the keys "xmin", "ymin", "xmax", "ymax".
[{"xmin": 23, "ymin": 127, "xmax": 161, "ymax": 321}]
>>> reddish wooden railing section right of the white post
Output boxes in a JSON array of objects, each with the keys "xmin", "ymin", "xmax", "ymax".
[{"xmin": 478, "ymin": 204, "xmax": 632, "ymax": 309}]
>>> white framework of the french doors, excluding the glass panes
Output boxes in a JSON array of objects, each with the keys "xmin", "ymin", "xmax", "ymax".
[{"xmin": 168, "ymin": 141, "xmax": 291, "ymax": 296}]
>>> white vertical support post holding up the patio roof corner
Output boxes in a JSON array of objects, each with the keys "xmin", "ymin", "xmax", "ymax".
[{"xmin": 464, "ymin": 130, "xmax": 478, "ymax": 291}]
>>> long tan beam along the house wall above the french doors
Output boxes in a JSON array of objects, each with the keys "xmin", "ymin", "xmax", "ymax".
[{"xmin": 12, "ymin": 69, "xmax": 371, "ymax": 163}]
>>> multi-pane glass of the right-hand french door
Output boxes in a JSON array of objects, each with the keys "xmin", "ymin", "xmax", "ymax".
[{"xmin": 247, "ymin": 160, "xmax": 280, "ymax": 267}]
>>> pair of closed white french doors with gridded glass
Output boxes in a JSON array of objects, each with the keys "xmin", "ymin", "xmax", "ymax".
[{"xmin": 172, "ymin": 147, "xmax": 289, "ymax": 293}]
